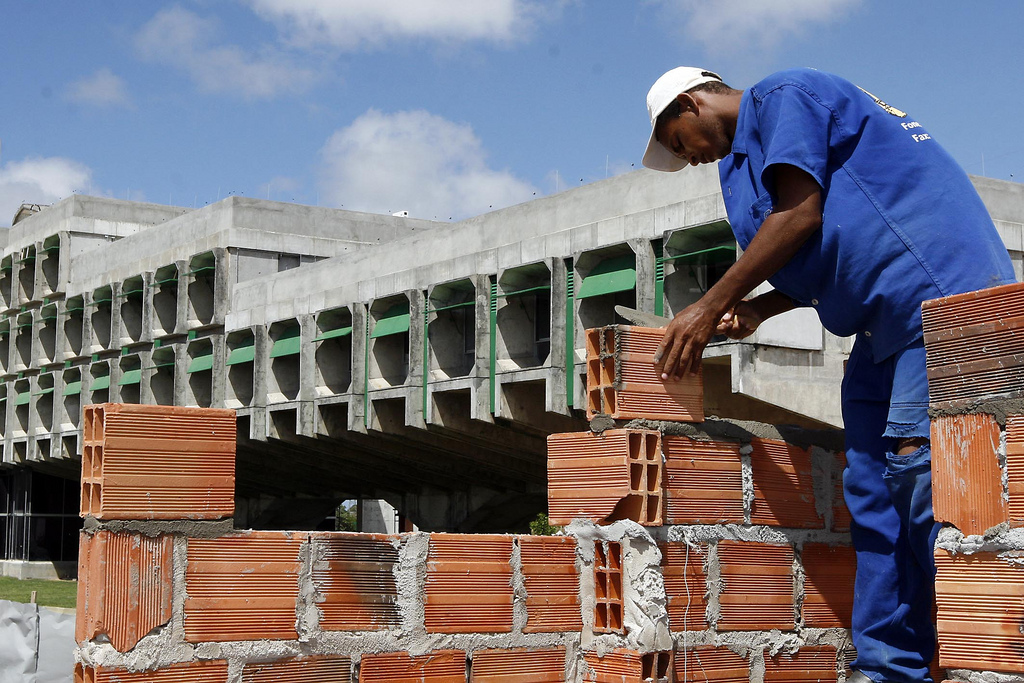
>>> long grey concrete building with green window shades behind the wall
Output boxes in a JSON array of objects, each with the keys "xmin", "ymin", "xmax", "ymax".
[{"xmin": 0, "ymin": 167, "xmax": 1024, "ymax": 571}]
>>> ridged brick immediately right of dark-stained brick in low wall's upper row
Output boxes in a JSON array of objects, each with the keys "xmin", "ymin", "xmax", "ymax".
[{"xmin": 424, "ymin": 533, "xmax": 512, "ymax": 633}]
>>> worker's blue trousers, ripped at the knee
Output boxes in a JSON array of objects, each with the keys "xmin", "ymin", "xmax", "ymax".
[{"xmin": 843, "ymin": 339, "xmax": 939, "ymax": 683}]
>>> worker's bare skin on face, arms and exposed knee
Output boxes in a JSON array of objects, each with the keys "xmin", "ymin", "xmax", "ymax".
[{"xmin": 654, "ymin": 90, "xmax": 928, "ymax": 455}]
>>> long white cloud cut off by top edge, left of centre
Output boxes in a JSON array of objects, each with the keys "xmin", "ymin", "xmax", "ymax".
[{"xmin": 248, "ymin": 0, "xmax": 548, "ymax": 49}]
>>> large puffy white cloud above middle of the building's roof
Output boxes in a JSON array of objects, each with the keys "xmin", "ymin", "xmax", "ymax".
[{"xmin": 319, "ymin": 110, "xmax": 536, "ymax": 220}]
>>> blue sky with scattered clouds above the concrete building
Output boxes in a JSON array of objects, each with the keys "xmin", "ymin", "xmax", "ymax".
[{"xmin": 0, "ymin": 0, "xmax": 1024, "ymax": 226}]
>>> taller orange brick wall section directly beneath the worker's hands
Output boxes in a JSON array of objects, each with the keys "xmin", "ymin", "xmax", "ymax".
[{"xmin": 561, "ymin": 326, "xmax": 856, "ymax": 682}]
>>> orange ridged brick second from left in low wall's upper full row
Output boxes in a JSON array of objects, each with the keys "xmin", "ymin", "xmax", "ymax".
[{"xmin": 185, "ymin": 531, "xmax": 307, "ymax": 643}]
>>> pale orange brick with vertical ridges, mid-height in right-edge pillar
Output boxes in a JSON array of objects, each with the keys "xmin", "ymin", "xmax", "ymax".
[{"xmin": 932, "ymin": 413, "xmax": 1009, "ymax": 535}]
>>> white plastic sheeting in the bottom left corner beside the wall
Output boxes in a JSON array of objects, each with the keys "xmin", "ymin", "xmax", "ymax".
[{"xmin": 0, "ymin": 600, "xmax": 75, "ymax": 683}]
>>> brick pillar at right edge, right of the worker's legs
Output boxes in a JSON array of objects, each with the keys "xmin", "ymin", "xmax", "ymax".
[{"xmin": 922, "ymin": 285, "xmax": 1024, "ymax": 681}]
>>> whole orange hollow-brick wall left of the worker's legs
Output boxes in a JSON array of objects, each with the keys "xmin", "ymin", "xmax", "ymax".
[{"xmin": 76, "ymin": 321, "xmax": 880, "ymax": 683}]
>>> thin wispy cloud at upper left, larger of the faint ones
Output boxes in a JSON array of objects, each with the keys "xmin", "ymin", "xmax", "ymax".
[{"xmin": 135, "ymin": 6, "xmax": 315, "ymax": 99}]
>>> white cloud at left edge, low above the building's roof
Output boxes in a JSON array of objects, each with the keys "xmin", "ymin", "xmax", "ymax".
[{"xmin": 0, "ymin": 157, "xmax": 92, "ymax": 225}]
